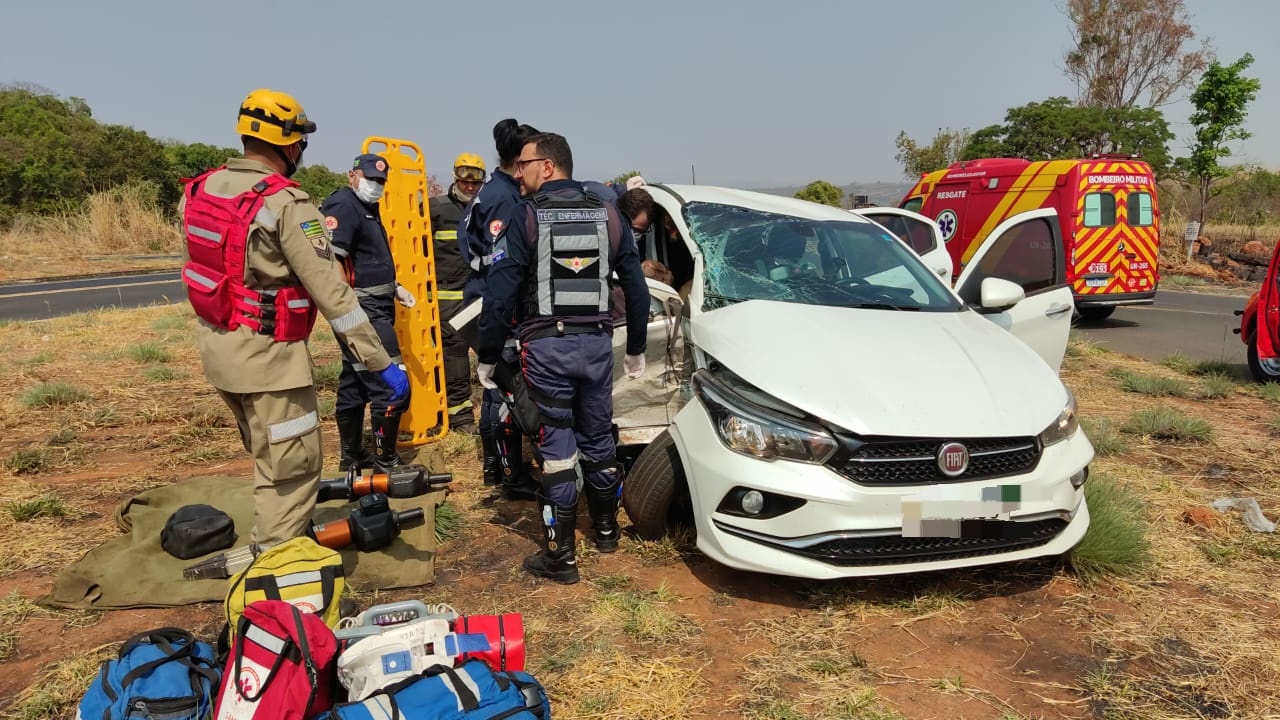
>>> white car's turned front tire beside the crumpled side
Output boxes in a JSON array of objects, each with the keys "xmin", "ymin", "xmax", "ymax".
[{"xmin": 622, "ymin": 432, "xmax": 694, "ymax": 541}]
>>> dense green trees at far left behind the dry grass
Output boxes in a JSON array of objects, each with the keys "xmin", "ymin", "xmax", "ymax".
[{"xmin": 0, "ymin": 85, "xmax": 347, "ymax": 227}]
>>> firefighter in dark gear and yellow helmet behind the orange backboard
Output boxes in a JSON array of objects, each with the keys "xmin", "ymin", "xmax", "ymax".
[{"xmin": 430, "ymin": 152, "xmax": 486, "ymax": 430}]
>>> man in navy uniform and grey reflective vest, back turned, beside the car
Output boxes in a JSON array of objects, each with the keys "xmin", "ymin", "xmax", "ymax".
[{"xmin": 476, "ymin": 133, "xmax": 649, "ymax": 583}]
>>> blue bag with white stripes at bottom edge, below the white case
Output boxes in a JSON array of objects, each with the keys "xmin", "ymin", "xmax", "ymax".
[{"xmin": 321, "ymin": 660, "xmax": 552, "ymax": 720}]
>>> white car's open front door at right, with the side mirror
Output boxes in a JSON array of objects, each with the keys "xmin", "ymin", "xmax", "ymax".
[{"xmin": 955, "ymin": 208, "xmax": 1075, "ymax": 372}]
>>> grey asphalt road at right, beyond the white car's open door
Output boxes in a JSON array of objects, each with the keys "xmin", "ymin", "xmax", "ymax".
[{"xmin": 1075, "ymin": 290, "xmax": 1251, "ymax": 378}]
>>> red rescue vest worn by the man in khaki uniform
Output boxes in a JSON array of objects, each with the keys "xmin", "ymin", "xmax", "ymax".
[{"xmin": 182, "ymin": 168, "xmax": 324, "ymax": 342}]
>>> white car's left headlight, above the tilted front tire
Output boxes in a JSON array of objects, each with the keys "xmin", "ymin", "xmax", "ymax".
[{"xmin": 692, "ymin": 370, "xmax": 837, "ymax": 464}]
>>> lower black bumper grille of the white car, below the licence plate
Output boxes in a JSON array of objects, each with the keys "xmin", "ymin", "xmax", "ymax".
[{"xmin": 721, "ymin": 518, "xmax": 1068, "ymax": 566}]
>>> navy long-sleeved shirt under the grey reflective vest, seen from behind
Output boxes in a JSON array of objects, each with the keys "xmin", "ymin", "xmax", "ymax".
[{"xmin": 476, "ymin": 179, "xmax": 649, "ymax": 364}]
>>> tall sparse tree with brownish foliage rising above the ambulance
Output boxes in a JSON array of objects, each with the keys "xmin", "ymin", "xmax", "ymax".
[{"xmin": 1064, "ymin": 0, "xmax": 1210, "ymax": 108}]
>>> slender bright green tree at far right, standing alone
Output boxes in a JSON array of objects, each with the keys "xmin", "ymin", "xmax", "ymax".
[{"xmin": 1178, "ymin": 53, "xmax": 1262, "ymax": 224}]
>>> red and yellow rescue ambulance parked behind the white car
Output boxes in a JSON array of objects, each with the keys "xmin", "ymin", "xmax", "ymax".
[{"xmin": 899, "ymin": 155, "xmax": 1160, "ymax": 320}]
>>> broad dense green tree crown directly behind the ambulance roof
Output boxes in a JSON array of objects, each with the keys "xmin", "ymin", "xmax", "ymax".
[{"xmin": 961, "ymin": 97, "xmax": 1174, "ymax": 176}]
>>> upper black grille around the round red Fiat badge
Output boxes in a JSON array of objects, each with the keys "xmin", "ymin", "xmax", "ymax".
[{"xmin": 827, "ymin": 434, "xmax": 1041, "ymax": 486}]
